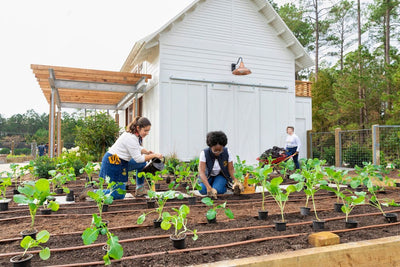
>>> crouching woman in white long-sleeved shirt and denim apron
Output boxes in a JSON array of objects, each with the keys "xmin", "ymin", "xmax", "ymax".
[{"xmin": 99, "ymin": 116, "xmax": 162, "ymax": 199}]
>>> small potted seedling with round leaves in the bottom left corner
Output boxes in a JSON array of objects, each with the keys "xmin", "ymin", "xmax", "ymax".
[{"xmin": 10, "ymin": 230, "xmax": 50, "ymax": 266}]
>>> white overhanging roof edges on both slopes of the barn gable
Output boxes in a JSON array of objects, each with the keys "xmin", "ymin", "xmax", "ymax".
[{"xmin": 121, "ymin": 0, "xmax": 314, "ymax": 72}]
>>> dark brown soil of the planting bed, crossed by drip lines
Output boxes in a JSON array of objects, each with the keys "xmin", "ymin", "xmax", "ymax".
[{"xmin": 0, "ymin": 177, "xmax": 400, "ymax": 266}]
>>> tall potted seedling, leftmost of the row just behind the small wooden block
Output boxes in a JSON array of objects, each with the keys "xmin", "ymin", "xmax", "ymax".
[{"xmin": 248, "ymin": 164, "xmax": 273, "ymax": 220}]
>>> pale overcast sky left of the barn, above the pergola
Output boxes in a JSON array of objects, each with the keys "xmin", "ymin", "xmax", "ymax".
[{"xmin": 0, "ymin": 0, "xmax": 193, "ymax": 118}]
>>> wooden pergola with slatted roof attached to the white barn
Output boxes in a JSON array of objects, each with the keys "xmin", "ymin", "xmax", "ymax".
[{"xmin": 31, "ymin": 64, "xmax": 151, "ymax": 157}]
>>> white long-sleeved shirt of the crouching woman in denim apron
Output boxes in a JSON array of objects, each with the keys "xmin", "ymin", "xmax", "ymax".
[{"xmin": 108, "ymin": 132, "xmax": 145, "ymax": 163}]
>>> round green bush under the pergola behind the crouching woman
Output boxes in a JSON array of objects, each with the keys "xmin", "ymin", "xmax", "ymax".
[{"xmin": 75, "ymin": 113, "xmax": 119, "ymax": 160}]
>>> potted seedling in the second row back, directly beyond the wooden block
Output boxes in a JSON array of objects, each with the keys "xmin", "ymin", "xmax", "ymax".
[{"xmin": 321, "ymin": 167, "xmax": 348, "ymax": 212}]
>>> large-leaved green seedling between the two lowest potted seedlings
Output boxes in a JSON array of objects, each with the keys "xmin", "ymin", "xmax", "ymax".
[{"xmin": 82, "ymin": 213, "xmax": 124, "ymax": 265}]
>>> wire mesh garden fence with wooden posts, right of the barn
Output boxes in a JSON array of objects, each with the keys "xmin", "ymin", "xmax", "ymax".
[{"xmin": 307, "ymin": 125, "xmax": 400, "ymax": 168}]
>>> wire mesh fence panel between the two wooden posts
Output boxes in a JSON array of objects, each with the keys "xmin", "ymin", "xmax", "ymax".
[{"xmin": 339, "ymin": 129, "xmax": 372, "ymax": 168}]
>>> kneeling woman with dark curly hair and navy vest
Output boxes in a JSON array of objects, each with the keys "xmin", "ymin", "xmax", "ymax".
[{"xmin": 199, "ymin": 131, "xmax": 243, "ymax": 198}]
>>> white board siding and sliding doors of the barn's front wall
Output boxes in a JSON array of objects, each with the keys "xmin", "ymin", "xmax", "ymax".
[{"xmin": 153, "ymin": 0, "xmax": 304, "ymax": 163}]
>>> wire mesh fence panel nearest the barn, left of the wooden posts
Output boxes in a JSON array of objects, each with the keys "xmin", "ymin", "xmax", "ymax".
[{"xmin": 310, "ymin": 132, "xmax": 335, "ymax": 165}]
